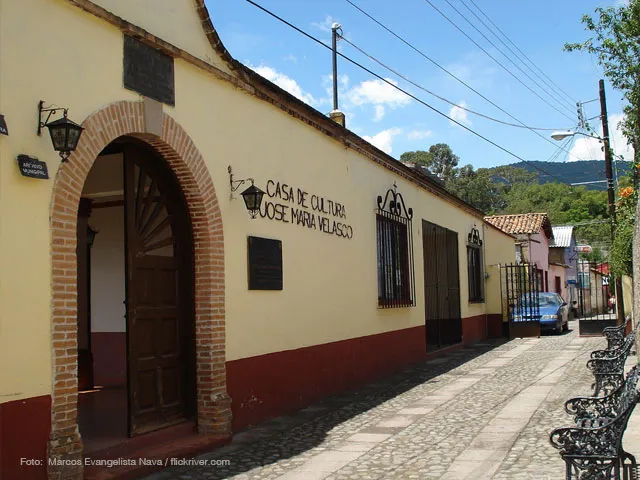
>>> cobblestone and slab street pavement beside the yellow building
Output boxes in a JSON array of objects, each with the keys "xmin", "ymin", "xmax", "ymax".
[{"xmin": 147, "ymin": 322, "xmax": 640, "ymax": 480}]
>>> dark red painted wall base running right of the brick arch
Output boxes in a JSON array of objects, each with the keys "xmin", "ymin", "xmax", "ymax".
[{"xmin": 227, "ymin": 315, "xmax": 486, "ymax": 431}]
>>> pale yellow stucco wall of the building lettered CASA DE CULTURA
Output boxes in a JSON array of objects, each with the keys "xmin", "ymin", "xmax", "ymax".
[{"xmin": 0, "ymin": 0, "xmax": 514, "ymax": 401}]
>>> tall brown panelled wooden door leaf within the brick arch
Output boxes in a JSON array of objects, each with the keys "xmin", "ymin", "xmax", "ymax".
[{"xmin": 124, "ymin": 142, "xmax": 195, "ymax": 435}]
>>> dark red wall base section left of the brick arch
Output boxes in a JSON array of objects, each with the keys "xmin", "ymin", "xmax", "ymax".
[{"xmin": 0, "ymin": 395, "xmax": 51, "ymax": 480}]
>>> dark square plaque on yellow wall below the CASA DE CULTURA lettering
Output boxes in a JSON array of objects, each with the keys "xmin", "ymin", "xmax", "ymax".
[{"xmin": 247, "ymin": 237, "xmax": 282, "ymax": 290}]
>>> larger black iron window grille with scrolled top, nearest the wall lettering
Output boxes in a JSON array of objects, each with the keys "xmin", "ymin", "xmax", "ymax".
[{"xmin": 376, "ymin": 189, "xmax": 416, "ymax": 308}]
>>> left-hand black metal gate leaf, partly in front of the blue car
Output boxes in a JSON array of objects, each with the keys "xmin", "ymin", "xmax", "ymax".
[{"xmin": 500, "ymin": 264, "xmax": 542, "ymax": 338}]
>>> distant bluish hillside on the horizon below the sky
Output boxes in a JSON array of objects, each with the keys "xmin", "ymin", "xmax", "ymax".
[{"xmin": 489, "ymin": 160, "xmax": 631, "ymax": 190}]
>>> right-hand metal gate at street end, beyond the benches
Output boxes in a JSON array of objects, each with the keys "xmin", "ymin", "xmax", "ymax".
[{"xmin": 576, "ymin": 260, "xmax": 616, "ymax": 335}]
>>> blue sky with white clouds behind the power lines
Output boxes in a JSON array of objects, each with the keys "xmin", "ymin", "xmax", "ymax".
[{"xmin": 207, "ymin": 0, "xmax": 632, "ymax": 168}]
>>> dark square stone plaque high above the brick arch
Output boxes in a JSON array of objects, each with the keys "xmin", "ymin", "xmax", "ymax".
[{"xmin": 124, "ymin": 35, "xmax": 176, "ymax": 105}]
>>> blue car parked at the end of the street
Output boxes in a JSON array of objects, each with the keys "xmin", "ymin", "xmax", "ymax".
[{"xmin": 513, "ymin": 292, "xmax": 569, "ymax": 333}]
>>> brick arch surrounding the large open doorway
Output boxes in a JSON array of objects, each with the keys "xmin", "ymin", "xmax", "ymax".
[{"xmin": 48, "ymin": 101, "xmax": 231, "ymax": 478}]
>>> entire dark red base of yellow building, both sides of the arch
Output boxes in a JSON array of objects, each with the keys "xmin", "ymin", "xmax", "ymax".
[{"xmin": 0, "ymin": 315, "xmax": 492, "ymax": 474}]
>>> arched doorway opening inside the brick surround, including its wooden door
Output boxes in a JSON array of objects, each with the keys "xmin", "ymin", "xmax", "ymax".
[{"xmin": 77, "ymin": 137, "xmax": 196, "ymax": 455}]
